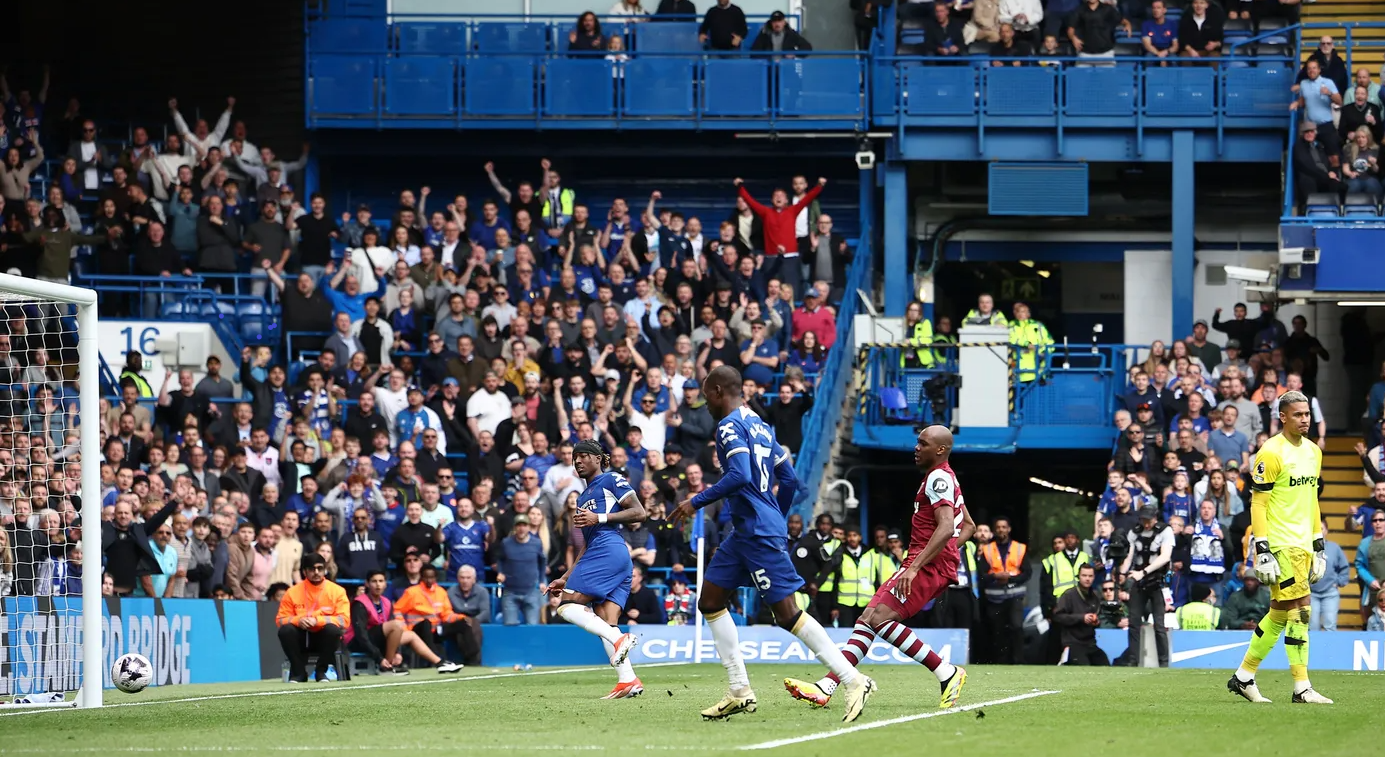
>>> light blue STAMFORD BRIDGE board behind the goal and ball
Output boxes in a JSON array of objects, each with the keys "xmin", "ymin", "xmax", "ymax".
[{"xmin": 0, "ymin": 596, "xmax": 260, "ymax": 696}]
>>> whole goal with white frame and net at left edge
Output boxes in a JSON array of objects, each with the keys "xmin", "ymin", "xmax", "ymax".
[{"xmin": 0, "ymin": 274, "xmax": 104, "ymax": 707}]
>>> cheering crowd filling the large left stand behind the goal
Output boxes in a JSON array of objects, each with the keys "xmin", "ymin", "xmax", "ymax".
[{"xmin": 0, "ymin": 79, "xmax": 852, "ymax": 667}]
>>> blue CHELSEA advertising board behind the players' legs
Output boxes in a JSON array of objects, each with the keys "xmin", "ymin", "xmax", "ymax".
[{"xmin": 481, "ymin": 626, "xmax": 970, "ymax": 667}]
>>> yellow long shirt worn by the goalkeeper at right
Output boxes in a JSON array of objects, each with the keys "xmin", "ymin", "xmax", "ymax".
[{"xmin": 1251, "ymin": 433, "xmax": 1323, "ymax": 552}]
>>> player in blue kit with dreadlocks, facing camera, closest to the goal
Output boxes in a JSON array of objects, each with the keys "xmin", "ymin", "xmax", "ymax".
[{"xmin": 548, "ymin": 439, "xmax": 645, "ymax": 699}]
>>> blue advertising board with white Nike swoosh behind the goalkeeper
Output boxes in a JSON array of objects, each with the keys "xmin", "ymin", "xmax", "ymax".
[{"xmin": 1097, "ymin": 630, "xmax": 1385, "ymax": 671}]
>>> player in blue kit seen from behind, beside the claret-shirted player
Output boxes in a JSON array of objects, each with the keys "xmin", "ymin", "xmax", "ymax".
[{"xmin": 669, "ymin": 365, "xmax": 875, "ymax": 722}]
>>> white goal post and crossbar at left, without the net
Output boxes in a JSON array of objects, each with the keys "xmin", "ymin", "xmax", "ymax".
[{"xmin": 0, "ymin": 274, "xmax": 105, "ymax": 707}]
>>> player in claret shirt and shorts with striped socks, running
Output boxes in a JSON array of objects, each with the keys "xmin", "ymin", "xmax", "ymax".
[{"xmin": 784, "ymin": 426, "xmax": 976, "ymax": 707}]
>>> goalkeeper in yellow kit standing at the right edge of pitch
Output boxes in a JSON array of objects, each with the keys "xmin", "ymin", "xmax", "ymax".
[{"xmin": 1226, "ymin": 392, "xmax": 1332, "ymax": 704}]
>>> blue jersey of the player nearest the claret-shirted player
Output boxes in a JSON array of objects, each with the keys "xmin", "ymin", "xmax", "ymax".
[{"xmin": 716, "ymin": 405, "xmax": 788, "ymax": 537}]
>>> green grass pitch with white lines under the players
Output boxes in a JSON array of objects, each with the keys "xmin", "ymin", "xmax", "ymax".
[{"xmin": 0, "ymin": 664, "xmax": 1385, "ymax": 757}]
